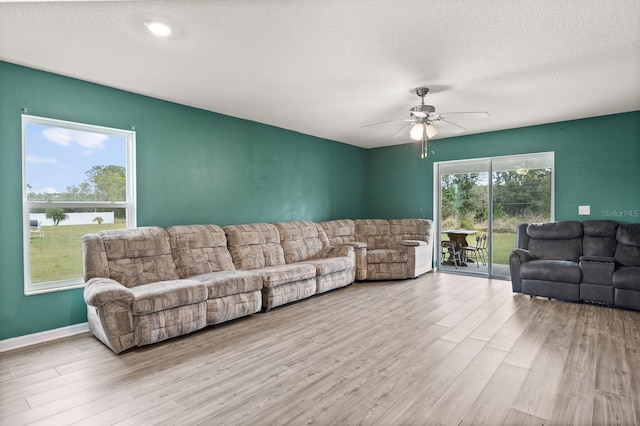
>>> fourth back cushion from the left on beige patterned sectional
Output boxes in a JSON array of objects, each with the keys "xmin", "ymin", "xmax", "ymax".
[{"xmin": 274, "ymin": 220, "xmax": 323, "ymax": 263}]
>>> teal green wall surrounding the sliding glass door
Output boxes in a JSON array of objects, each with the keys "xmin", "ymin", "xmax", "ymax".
[{"xmin": 366, "ymin": 111, "xmax": 640, "ymax": 223}]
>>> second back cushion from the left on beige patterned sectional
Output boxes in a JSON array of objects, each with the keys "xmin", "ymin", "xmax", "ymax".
[{"xmin": 167, "ymin": 225, "xmax": 236, "ymax": 278}]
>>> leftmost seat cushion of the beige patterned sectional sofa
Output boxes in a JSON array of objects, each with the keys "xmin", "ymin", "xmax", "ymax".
[{"xmin": 131, "ymin": 280, "xmax": 207, "ymax": 315}]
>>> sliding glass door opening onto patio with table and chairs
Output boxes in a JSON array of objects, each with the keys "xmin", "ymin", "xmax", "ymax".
[{"xmin": 434, "ymin": 153, "xmax": 553, "ymax": 278}]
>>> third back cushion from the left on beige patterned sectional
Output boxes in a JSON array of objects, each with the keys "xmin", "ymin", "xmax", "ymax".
[{"xmin": 223, "ymin": 223, "xmax": 285, "ymax": 270}]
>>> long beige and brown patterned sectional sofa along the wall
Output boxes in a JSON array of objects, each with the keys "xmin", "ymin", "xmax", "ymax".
[{"xmin": 82, "ymin": 219, "xmax": 433, "ymax": 353}]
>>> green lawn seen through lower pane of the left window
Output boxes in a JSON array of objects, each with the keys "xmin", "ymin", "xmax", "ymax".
[{"xmin": 31, "ymin": 220, "xmax": 126, "ymax": 283}]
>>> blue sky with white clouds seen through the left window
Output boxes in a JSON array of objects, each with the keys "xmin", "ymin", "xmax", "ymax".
[{"xmin": 26, "ymin": 123, "xmax": 126, "ymax": 193}]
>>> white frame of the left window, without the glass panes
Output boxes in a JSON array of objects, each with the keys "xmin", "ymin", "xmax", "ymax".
[{"xmin": 22, "ymin": 114, "xmax": 136, "ymax": 295}]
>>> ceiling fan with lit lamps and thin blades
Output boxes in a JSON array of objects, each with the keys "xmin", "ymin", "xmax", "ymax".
[{"xmin": 362, "ymin": 87, "xmax": 489, "ymax": 158}]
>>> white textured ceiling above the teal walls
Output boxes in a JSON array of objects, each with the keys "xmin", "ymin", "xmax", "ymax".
[{"xmin": 0, "ymin": 0, "xmax": 640, "ymax": 148}]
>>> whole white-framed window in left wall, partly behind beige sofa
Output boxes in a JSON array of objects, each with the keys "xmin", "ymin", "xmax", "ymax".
[{"xmin": 22, "ymin": 115, "xmax": 136, "ymax": 294}]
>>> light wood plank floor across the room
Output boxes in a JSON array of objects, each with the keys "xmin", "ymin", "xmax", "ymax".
[{"xmin": 0, "ymin": 273, "xmax": 640, "ymax": 425}]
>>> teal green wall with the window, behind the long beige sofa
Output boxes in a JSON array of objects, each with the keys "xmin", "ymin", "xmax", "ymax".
[{"xmin": 0, "ymin": 62, "xmax": 366, "ymax": 340}]
